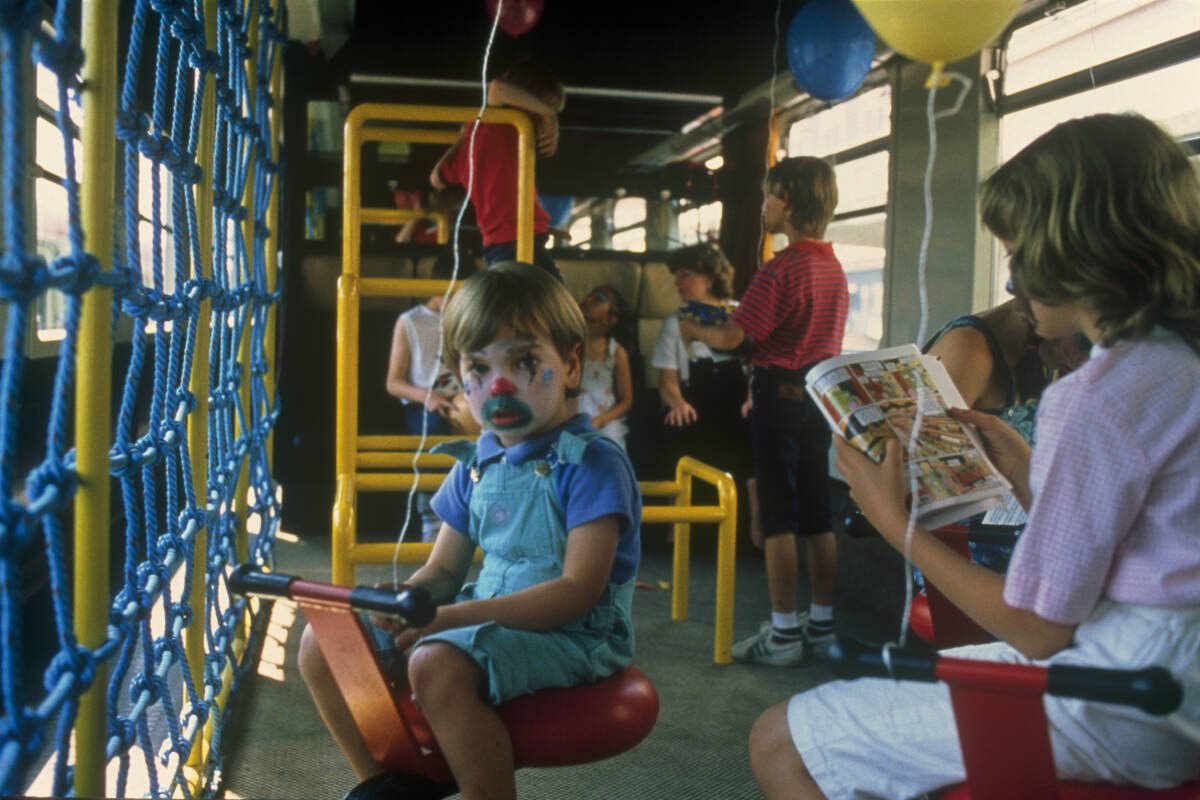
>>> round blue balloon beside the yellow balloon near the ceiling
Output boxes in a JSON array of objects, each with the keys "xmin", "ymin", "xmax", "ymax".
[{"xmin": 787, "ymin": 0, "xmax": 875, "ymax": 102}]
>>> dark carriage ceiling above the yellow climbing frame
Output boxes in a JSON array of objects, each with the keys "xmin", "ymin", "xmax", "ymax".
[{"xmin": 288, "ymin": 0, "xmax": 825, "ymax": 196}]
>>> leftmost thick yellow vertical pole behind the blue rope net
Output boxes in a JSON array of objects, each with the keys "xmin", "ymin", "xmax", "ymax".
[{"xmin": 73, "ymin": 0, "xmax": 119, "ymax": 798}]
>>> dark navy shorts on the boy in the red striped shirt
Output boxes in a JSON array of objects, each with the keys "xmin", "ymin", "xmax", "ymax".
[{"xmin": 750, "ymin": 366, "xmax": 833, "ymax": 536}]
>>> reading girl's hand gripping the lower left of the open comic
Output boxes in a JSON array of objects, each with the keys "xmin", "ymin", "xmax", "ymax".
[{"xmin": 833, "ymin": 434, "xmax": 908, "ymax": 548}]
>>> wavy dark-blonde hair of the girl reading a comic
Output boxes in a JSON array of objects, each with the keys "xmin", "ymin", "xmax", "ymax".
[{"xmin": 979, "ymin": 114, "xmax": 1200, "ymax": 350}]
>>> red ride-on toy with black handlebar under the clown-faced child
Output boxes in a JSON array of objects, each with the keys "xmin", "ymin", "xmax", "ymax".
[{"xmin": 229, "ymin": 564, "xmax": 659, "ymax": 800}]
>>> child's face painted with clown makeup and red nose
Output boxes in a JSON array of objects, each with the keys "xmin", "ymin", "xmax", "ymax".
[{"xmin": 458, "ymin": 329, "xmax": 580, "ymax": 447}]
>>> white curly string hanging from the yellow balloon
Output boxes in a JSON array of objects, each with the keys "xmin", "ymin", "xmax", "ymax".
[{"xmin": 900, "ymin": 72, "xmax": 971, "ymax": 648}]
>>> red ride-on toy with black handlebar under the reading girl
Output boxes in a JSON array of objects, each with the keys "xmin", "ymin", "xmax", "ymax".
[{"xmin": 830, "ymin": 640, "xmax": 1200, "ymax": 800}]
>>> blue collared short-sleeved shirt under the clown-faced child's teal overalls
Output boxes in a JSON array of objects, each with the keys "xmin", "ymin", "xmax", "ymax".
[{"xmin": 431, "ymin": 414, "xmax": 642, "ymax": 583}]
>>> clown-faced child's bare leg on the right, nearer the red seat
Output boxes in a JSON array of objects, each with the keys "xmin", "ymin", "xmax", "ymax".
[{"xmin": 408, "ymin": 642, "xmax": 517, "ymax": 800}]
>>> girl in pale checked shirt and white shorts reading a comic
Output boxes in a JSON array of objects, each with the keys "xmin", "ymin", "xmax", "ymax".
[{"xmin": 750, "ymin": 114, "xmax": 1200, "ymax": 799}]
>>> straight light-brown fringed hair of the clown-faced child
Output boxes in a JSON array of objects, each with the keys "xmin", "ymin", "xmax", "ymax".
[{"xmin": 442, "ymin": 261, "xmax": 588, "ymax": 396}]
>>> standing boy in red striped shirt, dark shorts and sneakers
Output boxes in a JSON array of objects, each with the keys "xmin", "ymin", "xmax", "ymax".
[{"xmin": 679, "ymin": 156, "xmax": 850, "ymax": 666}]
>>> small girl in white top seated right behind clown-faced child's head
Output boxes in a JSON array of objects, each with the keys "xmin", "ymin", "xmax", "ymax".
[{"xmin": 580, "ymin": 287, "xmax": 634, "ymax": 447}]
